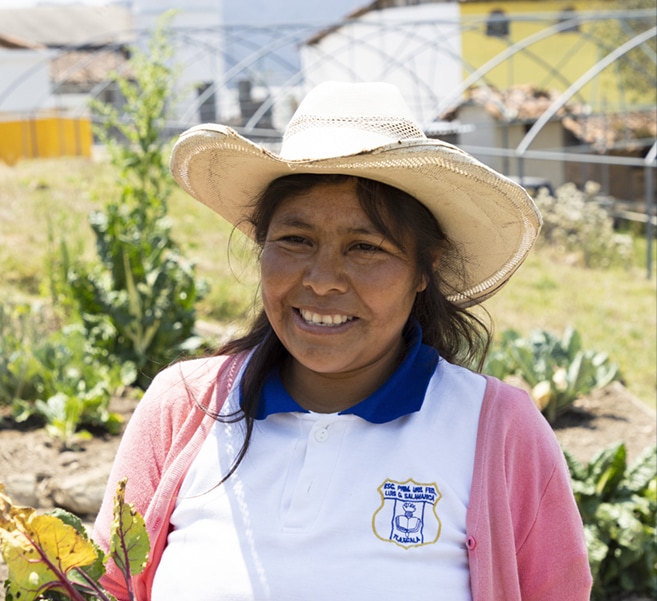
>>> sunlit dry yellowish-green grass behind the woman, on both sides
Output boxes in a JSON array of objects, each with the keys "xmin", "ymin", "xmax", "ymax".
[{"xmin": 0, "ymin": 159, "xmax": 657, "ymax": 407}]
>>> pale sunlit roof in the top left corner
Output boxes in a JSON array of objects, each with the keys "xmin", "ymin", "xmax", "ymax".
[{"xmin": 0, "ymin": 4, "xmax": 134, "ymax": 48}]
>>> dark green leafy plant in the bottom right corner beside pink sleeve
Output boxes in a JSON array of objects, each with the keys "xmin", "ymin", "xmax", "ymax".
[{"xmin": 564, "ymin": 443, "xmax": 657, "ymax": 601}]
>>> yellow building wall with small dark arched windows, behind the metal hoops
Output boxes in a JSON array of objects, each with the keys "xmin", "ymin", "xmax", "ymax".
[{"xmin": 461, "ymin": 0, "xmax": 644, "ymax": 111}]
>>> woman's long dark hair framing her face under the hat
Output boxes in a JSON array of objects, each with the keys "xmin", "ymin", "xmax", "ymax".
[{"xmin": 208, "ymin": 174, "xmax": 491, "ymax": 480}]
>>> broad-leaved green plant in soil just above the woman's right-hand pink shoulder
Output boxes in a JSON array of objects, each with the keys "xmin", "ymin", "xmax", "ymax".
[{"xmin": 484, "ymin": 328, "xmax": 619, "ymax": 423}]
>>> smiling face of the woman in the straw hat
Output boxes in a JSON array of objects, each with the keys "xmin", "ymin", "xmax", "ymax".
[{"xmin": 261, "ymin": 180, "xmax": 424, "ymax": 404}]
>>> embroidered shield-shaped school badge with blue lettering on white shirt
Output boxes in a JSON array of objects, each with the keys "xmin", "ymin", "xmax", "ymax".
[{"xmin": 372, "ymin": 480, "xmax": 442, "ymax": 549}]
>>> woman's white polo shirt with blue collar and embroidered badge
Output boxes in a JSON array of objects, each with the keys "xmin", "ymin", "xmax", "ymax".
[{"xmin": 152, "ymin": 332, "xmax": 485, "ymax": 601}]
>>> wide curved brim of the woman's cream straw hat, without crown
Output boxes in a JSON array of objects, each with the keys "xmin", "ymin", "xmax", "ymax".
[{"xmin": 171, "ymin": 124, "xmax": 541, "ymax": 306}]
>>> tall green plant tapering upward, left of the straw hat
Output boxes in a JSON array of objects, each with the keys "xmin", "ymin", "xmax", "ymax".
[{"xmin": 68, "ymin": 21, "xmax": 204, "ymax": 387}]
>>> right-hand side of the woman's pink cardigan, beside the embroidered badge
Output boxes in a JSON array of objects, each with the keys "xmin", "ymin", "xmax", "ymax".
[{"xmin": 468, "ymin": 378, "xmax": 591, "ymax": 601}]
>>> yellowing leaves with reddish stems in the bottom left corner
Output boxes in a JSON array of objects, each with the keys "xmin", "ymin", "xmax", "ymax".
[{"xmin": 0, "ymin": 480, "xmax": 150, "ymax": 601}]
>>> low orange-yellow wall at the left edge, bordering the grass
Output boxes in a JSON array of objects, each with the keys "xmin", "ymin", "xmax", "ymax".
[{"xmin": 0, "ymin": 116, "xmax": 92, "ymax": 165}]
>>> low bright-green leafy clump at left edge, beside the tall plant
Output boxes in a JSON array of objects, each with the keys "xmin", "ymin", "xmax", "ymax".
[{"xmin": 0, "ymin": 305, "xmax": 135, "ymax": 447}]
